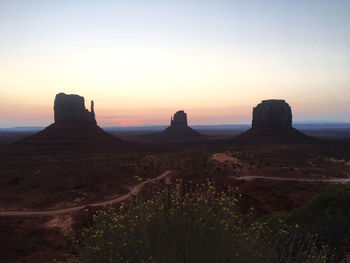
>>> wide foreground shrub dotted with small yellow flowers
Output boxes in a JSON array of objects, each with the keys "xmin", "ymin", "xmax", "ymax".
[{"xmin": 59, "ymin": 182, "xmax": 333, "ymax": 263}]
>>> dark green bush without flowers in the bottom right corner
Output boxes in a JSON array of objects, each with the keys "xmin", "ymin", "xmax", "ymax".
[{"xmin": 260, "ymin": 185, "xmax": 350, "ymax": 259}]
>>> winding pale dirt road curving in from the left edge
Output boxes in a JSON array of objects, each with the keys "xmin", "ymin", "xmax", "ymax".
[{"xmin": 0, "ymin": 170, "xmax": 172, "ymax": 216}]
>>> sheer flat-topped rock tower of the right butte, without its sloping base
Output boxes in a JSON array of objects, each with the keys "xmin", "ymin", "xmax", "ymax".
[{"xmin": 252, "ymin": 100, "xmax": 292, "ymax": 128}]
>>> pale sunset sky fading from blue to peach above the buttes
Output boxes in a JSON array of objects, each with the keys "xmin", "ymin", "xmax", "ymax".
[{"xmin": 0, "ymin": 0, "xmax": 350, "ymax": 127}]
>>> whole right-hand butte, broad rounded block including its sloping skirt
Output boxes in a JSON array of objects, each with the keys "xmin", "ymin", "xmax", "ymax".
[{"xmin": 237, "ymin": 99, "xmax": 309, "ymax": 142}]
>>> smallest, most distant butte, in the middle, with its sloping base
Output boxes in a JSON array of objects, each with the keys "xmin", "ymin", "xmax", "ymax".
[{"xmin": 161, "ymin": 110, "xmax": 203, "ymax": 140}]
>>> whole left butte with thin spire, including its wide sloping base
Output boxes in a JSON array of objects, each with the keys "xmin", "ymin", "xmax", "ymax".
[{"xmin": 20, "ymin": 93, "xmax": 126, "ymax": 147}]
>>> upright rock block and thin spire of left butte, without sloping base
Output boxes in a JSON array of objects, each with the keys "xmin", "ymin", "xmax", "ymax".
[{"xmin": 54, "ymin": 93, "xmax": 97, "ymax": 125}]
